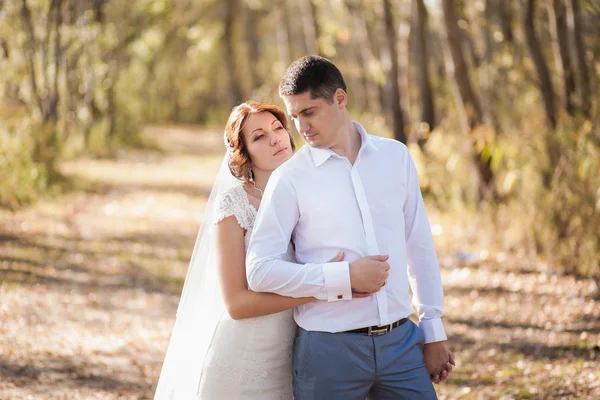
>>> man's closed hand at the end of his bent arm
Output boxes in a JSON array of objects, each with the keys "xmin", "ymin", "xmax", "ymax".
[{"xmin": 350, "ymin": 256, "xmax": 390, "ymax": 293}]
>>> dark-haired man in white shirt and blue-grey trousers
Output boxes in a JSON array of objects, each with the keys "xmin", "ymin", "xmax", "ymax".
[{"xmin": 247, "ymin": 56, "xmax": 454, "ymax": 400}]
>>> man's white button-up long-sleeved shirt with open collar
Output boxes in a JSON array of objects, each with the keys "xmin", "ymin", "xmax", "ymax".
[{"xmin": 247, "ymin": 122, "xmax": 446, "ymax": 343}]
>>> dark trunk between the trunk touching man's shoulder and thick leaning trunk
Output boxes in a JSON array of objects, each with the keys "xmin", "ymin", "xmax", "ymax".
[{"xmin": 413, "ymin": 0, "xmax": 435, "ymax": 139}]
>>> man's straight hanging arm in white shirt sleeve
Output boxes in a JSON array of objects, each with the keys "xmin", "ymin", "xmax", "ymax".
[{"xmin": 403, "ymin": 147, "xmax": 446, "ymax": 343}]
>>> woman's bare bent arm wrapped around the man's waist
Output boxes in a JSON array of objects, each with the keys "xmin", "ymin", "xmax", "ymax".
[{"xmin": 214, "ymin": 216, "xmax": 315, "ymax": 319}]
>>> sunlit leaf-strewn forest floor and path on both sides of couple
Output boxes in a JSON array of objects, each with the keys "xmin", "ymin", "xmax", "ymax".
[{"xmin": 0, "ymin": 127, "xmax": 600, "ymax": 399}]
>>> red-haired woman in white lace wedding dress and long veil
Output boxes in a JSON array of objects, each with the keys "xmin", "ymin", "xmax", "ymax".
[{"xmin": 155, "ymin": 102, "xmax": 343, "ymax": 400}]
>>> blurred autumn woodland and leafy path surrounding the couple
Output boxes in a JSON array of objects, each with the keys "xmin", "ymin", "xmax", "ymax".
[{"xmin": 0, "ymin": 0, "xmax": 600, "ymax": 399}]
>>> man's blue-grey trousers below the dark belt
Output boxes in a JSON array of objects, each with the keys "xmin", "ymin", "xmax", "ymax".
[{"xmin": 294, "ymin": 321, "xmax": 437, "ymax": 400}]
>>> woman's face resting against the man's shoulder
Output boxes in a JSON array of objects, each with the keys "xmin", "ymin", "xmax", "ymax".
[{"xmin": 242, "ymin": 112, "xmax": 292, "ymax": 171}]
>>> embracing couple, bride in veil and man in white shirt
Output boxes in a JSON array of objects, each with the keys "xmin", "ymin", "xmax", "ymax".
[{"xmin": 155, "ymin": 56, "xmax": 454, "ymax": 400}]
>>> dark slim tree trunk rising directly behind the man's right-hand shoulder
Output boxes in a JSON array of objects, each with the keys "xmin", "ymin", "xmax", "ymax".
[{"xmin": 383, "ymin": 0, "xmax": 406, "ymax": 144}]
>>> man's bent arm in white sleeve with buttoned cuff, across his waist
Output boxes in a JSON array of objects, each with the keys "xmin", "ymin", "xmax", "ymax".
[{"xmin": 246, "ymin": 171, "xmax": 352, "ymax": 301}]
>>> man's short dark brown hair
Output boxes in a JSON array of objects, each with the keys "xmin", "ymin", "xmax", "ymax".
[{"xmin": 279, "ymin": 56, "xmax": 346, "ymax": 104}]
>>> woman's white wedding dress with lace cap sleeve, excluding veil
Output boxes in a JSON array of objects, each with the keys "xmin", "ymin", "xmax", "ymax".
[{"xmin": 199, "ymin": 186, "xmax": 296, "ymax": 400}]
